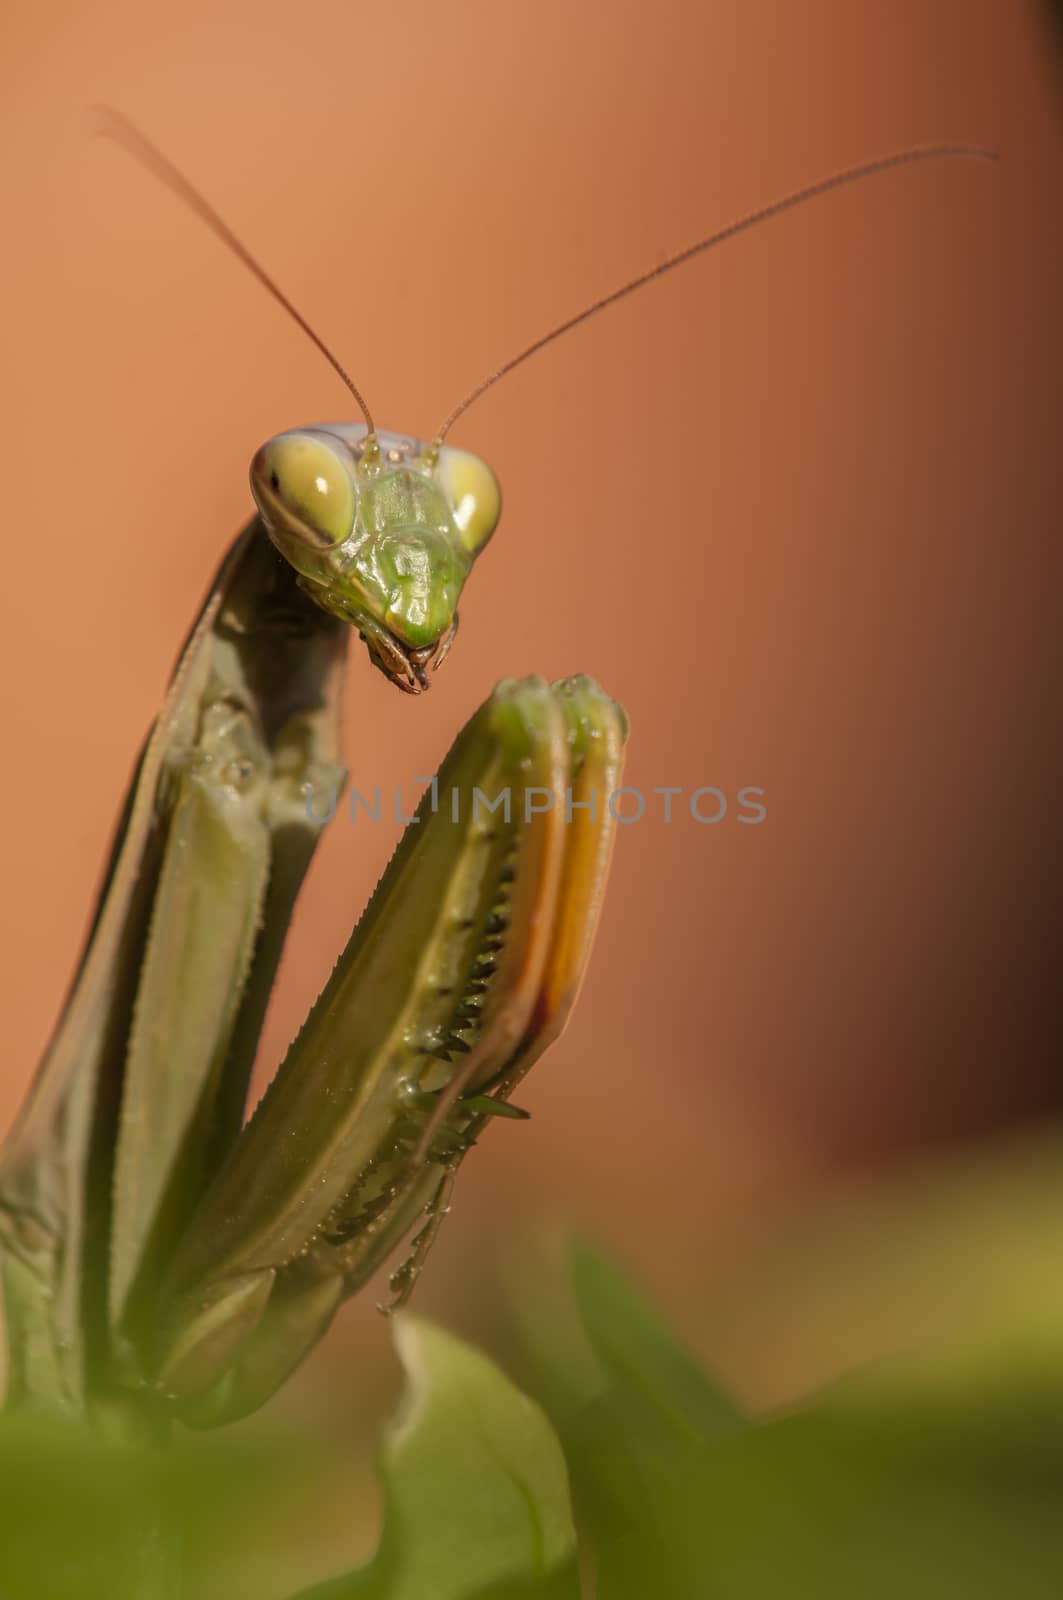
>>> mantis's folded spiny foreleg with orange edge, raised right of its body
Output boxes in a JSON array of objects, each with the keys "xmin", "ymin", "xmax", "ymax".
[{"xmin": 154, "ymin": 678, "xmax": 624, "ymax": 1424}]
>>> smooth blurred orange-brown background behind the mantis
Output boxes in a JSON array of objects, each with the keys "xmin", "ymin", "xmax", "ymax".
[{"xmin": 0, "ymin": 0, "xmax": 1063, "ymax": 1472}]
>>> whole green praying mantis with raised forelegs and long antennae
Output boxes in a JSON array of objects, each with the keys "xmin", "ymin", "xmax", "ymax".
[{"xmin": 0, "ymin": 114, "xmax": 989, "ymax": 1426}]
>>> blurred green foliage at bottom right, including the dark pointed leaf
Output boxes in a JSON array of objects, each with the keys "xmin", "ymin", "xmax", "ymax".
[{"xmin": 534, "ymin": 1248, "xmax": 1063, "ymax": 1600}]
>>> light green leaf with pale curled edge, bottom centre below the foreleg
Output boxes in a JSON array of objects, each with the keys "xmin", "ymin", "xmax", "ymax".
[{"xmin": 307, "ymin": 1317, "xmax": 580, "ymax": 1600}]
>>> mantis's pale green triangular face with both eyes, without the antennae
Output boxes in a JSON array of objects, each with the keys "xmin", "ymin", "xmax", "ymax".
[{"xmin": 251, "ymin": 422, "xmax": 501, "ymax": 693}]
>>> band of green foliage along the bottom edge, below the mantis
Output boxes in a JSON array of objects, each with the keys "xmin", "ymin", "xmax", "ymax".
[{"xmin": 0, "ymin": 1216, "xmax": 1063, "ymax": 1600}]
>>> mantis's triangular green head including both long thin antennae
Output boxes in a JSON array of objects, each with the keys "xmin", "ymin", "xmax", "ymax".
[{"xmin": 95, "ymin": 112, "xmax": 996, "ymax": 694}]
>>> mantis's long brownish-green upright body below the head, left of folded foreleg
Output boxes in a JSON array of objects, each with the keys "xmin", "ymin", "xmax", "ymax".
[{"xmin": 0, "ymin": 525, "xmax": 349, "ymax": 1411}]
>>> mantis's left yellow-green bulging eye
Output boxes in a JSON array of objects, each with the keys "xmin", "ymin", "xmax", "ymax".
[{"xmin": 251, "ymin": 434, "xmax": 355, "ymax": 546}]
